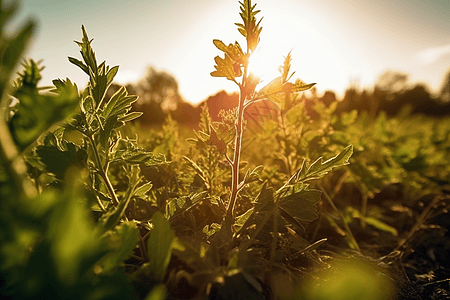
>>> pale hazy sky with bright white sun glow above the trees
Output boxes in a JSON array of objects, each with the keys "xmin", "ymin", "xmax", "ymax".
[{"xmin": 4, "ymin": 0, "xmax": 450, "ymax": 104}]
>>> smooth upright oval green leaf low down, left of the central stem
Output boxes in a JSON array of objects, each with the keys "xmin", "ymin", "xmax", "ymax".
[{"xmin": 146, "ymin": 212, "xmax": 175, "ymax": 281}]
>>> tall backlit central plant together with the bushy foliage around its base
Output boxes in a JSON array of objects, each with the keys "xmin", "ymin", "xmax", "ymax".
[{"xmin": 158, "ymin": 0, "xmax": 353, "ymax": 299}]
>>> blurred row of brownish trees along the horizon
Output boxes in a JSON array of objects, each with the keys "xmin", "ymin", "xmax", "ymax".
[{"xmin": 108, "ymin": 67, "xmax": 450, "ymax": 127}]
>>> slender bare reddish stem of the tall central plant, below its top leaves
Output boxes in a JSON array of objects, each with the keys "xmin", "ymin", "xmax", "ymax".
[{"xmin": 225, "ymin": 65, "xmax": 247, "ymax": 224}]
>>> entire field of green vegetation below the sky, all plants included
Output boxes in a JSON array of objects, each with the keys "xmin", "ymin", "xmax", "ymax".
[{"xmin": 0, "ymin": 0, "xmax": 450, "ymax": 300}]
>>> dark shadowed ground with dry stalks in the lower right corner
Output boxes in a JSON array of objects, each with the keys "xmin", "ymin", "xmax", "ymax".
[{"xmin": 312, "ymin": 184, "xmax": 450, "ymax": 300}]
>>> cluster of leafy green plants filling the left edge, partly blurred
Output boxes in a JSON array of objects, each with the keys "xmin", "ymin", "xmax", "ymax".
[{"xmin": 0, "ymin": 1, "xmax": 171, "ymax": 299}]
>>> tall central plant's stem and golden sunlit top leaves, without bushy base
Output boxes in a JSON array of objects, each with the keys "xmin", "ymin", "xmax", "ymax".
[{"xmin": 211, "ymin": 1, "xmax": 348, "ymax": 232}]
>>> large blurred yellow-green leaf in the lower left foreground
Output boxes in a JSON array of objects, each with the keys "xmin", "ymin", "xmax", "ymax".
[{"xmin": 30, "ymin": 181, "xmax": 107, "ymax": 287}]
